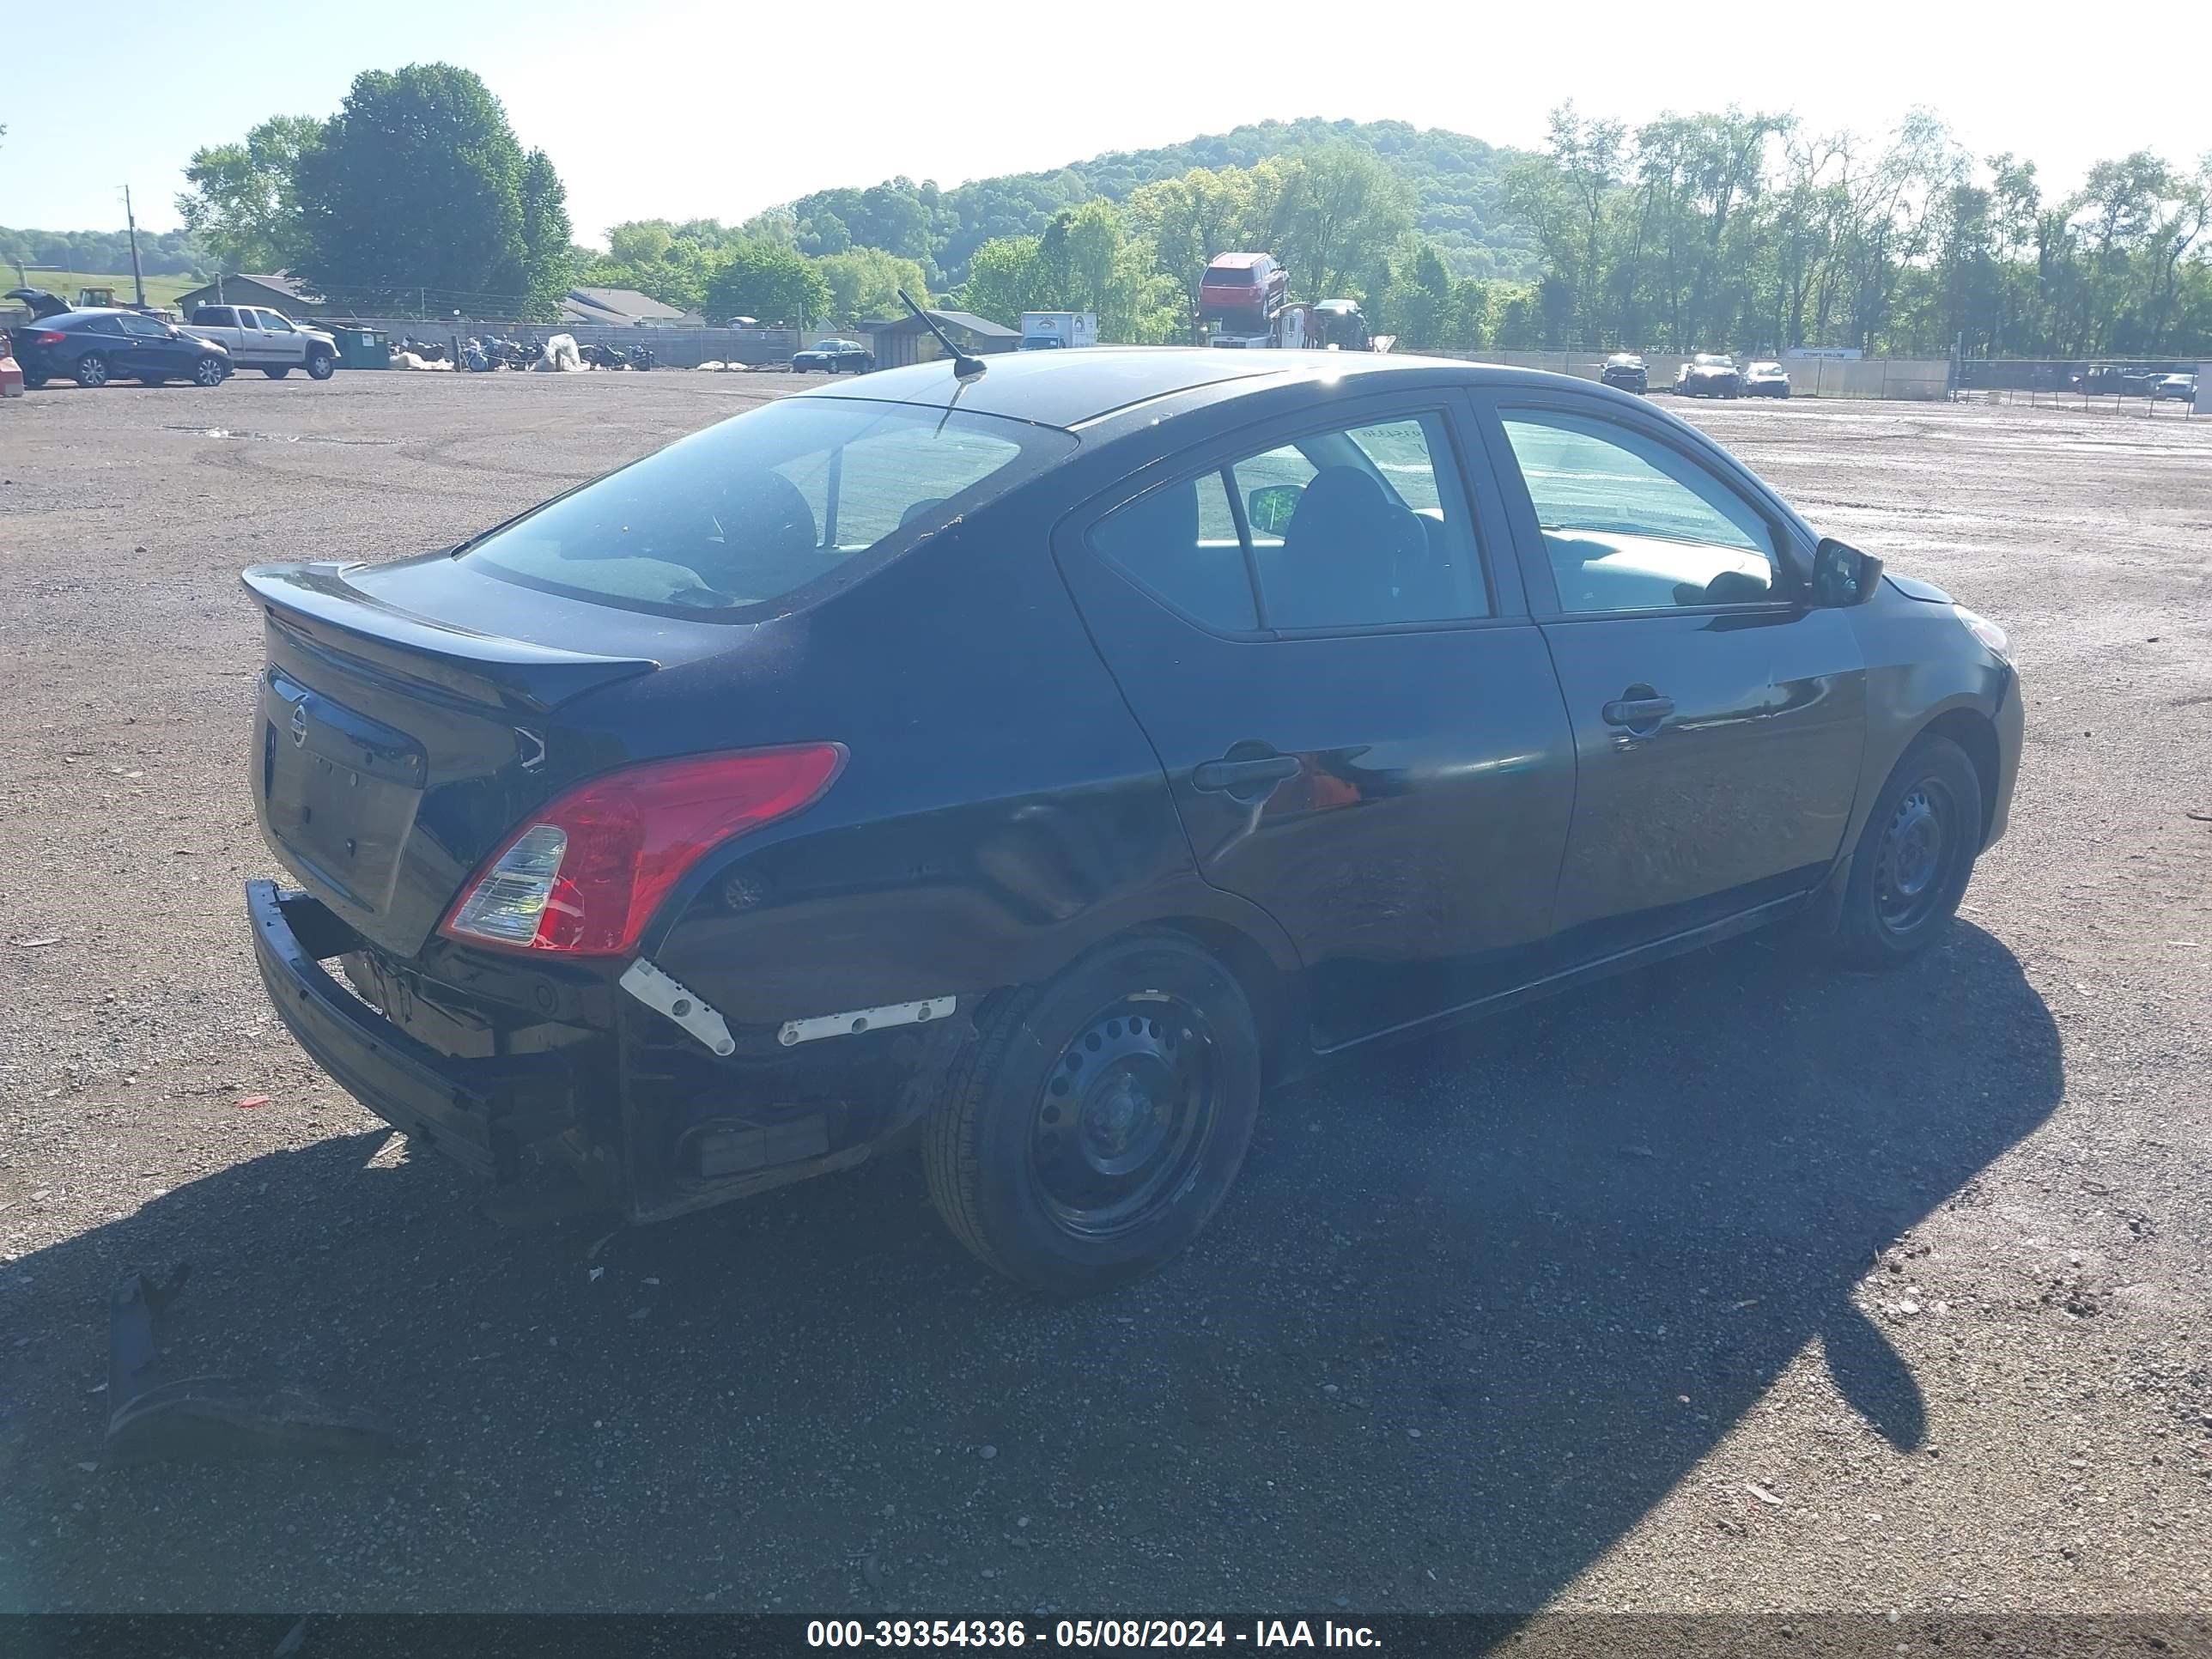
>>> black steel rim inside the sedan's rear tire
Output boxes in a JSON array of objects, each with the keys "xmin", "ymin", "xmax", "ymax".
[{"xmin": 1029, "ymin": 991, "xmax": 1224, "ymax": 1239}]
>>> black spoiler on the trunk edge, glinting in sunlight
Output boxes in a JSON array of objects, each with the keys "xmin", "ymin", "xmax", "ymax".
[{"xmin": 239, "ymin": 562, "xmax": 659, "ymax": 714}]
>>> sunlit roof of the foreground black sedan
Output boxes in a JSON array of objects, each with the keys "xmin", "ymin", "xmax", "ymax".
[{"xmin": 794, "ymin": 345, "xmax": 1595, "ymax": 429}]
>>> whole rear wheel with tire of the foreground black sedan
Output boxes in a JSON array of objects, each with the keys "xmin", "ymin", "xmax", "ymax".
[{"xmin": 922, "ymin": 933, "xmax": 1261, "ymax": 1297}]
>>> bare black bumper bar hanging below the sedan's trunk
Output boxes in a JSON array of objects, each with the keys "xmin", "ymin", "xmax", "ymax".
[{"xmin": 246, "ymin": 880, "xmax": 575, "ymax": 1182}]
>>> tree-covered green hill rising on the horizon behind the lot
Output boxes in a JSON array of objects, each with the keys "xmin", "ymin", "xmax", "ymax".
[{"xmin": 790, "ymin": 118, "xmax": 1537, "ymax": 289}]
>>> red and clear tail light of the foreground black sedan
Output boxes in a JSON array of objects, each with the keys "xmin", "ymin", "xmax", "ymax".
[{"xmin": 441, "ymin": 744, "xmax": 845, "ymax": 956}]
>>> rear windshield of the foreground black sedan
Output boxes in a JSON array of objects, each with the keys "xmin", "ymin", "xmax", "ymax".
[{"xmin": 460, "ymin": 398, "xmax": 1075, "ymax": 617}]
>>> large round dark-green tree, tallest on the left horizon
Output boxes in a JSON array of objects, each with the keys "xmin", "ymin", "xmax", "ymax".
[{"xmin": 299, "ymin": 64, "xmax": 568, "ymax": 312}]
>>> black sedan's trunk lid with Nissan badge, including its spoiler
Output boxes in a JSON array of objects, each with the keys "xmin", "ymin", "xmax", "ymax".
[{"xmin": 243, "ymin": 564, "xmax": 659, "ymax": 956}]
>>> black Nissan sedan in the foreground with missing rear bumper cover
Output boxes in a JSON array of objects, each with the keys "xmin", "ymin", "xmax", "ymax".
[{"xmin": 246, "ymin": 349, "xmax": 2021, "ymax": 1294}]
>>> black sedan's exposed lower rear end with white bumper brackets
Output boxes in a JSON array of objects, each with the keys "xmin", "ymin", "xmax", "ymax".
[{"xmin": 246, "ymin": 880, "xmax": 973, "ymax": 1221}]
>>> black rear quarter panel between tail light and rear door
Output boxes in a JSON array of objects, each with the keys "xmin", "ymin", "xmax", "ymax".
[{"xmin": 622, "ymin": 480, "xmax": 1294, "ymax": 1026}]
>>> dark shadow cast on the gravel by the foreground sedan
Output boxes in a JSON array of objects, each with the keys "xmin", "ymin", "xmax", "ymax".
[{"xmin": 0, "ymin": 925, "xmax": 2062, "ymax": 1617}]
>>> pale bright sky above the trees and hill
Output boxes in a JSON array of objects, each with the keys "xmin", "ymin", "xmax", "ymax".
[{"xmin": 0, "ymin": 0, "xmax": 2212, "ymax": 241}]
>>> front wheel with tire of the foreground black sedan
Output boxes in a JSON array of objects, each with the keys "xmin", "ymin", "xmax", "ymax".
[{"xmin": 1836, "ymin": 732, "xmax": 1982, "ymax": 969}]
